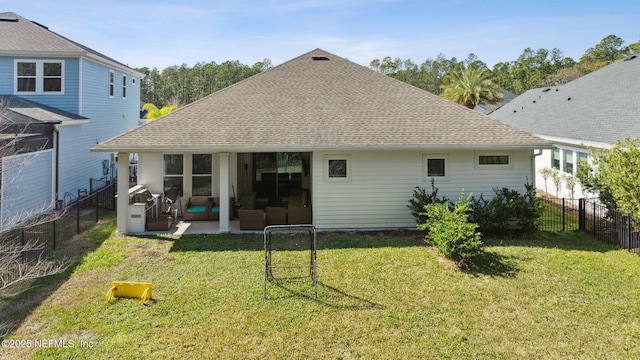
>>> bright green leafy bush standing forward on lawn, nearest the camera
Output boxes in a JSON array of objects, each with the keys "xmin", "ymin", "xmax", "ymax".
[{"xmin": 418, "ymin": 195, "xmax": 482, "ymax": 266}]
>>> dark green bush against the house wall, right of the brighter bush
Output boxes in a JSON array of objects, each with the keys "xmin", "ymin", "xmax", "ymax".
[{"xmin": 471, "ymin": 184, "xmax": 544, "ymax": 234}]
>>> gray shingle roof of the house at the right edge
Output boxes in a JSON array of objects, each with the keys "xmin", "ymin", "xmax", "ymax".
[{"xmin": 489, "ymin": 57, "xmax": 640, "ymax": 144}]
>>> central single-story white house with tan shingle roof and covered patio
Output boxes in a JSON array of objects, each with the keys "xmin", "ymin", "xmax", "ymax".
[{"xmin": 92, "ymin": 49, "xmax": 551, "ymax": 233}]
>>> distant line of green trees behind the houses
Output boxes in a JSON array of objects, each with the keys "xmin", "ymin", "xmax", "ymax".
[{"xmin": 136, "ymin": 35, "xmax": 640, "ymax": 108}]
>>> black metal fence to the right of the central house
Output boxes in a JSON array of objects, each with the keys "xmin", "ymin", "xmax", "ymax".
[{"xmin": 538, "ymin": 198, "xmax": 640, "ymax": 255}]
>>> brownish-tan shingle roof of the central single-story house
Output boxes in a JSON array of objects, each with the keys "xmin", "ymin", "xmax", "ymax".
[{"xmin": 94, "ymin": 49, "xmax": 549, "ymax": 152}]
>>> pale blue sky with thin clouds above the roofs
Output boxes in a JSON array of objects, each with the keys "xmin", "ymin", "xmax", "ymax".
[{"xmin": 5, "ymin": 0, "xmax": 640, "ymax": 70}]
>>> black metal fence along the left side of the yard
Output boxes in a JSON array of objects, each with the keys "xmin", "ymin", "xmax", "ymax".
[{"xmin": 0, "ymin": 181, "xmax": 117, "ymax": 288}]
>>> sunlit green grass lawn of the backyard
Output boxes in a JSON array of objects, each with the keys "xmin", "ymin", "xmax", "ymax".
[{"xmin": 0, "ymin": 215, "xmax": 640, "ymax": 359}]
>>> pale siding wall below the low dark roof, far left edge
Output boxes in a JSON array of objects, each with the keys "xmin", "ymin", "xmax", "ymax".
[{"xmin": 1, "ymin": 150, "xmax": 55, "ymax": 227}]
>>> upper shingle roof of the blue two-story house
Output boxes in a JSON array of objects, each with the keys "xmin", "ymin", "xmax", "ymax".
[{"xmin": 0, "ymin": 12, "xmax": 141, "ymax": 75}]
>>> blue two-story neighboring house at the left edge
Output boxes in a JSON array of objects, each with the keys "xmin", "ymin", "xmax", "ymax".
[{"xmin": 0, "ymin": 12, "xmax": 142, "ymax": 226}]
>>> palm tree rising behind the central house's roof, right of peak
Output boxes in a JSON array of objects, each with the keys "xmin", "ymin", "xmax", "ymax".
[{"xmin": 440, "ymin": 65, "xmax": 502, "ymax": 109}]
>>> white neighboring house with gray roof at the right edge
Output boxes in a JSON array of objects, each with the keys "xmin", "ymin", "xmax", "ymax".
[{"xmin": 489, "ymin": 55, "xmax": 640, "ymax": 198}]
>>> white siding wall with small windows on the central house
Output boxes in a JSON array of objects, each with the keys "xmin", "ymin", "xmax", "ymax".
[{"xmin": 312, "ymin": 151, "xmax": 532, "ymax": 229}]
